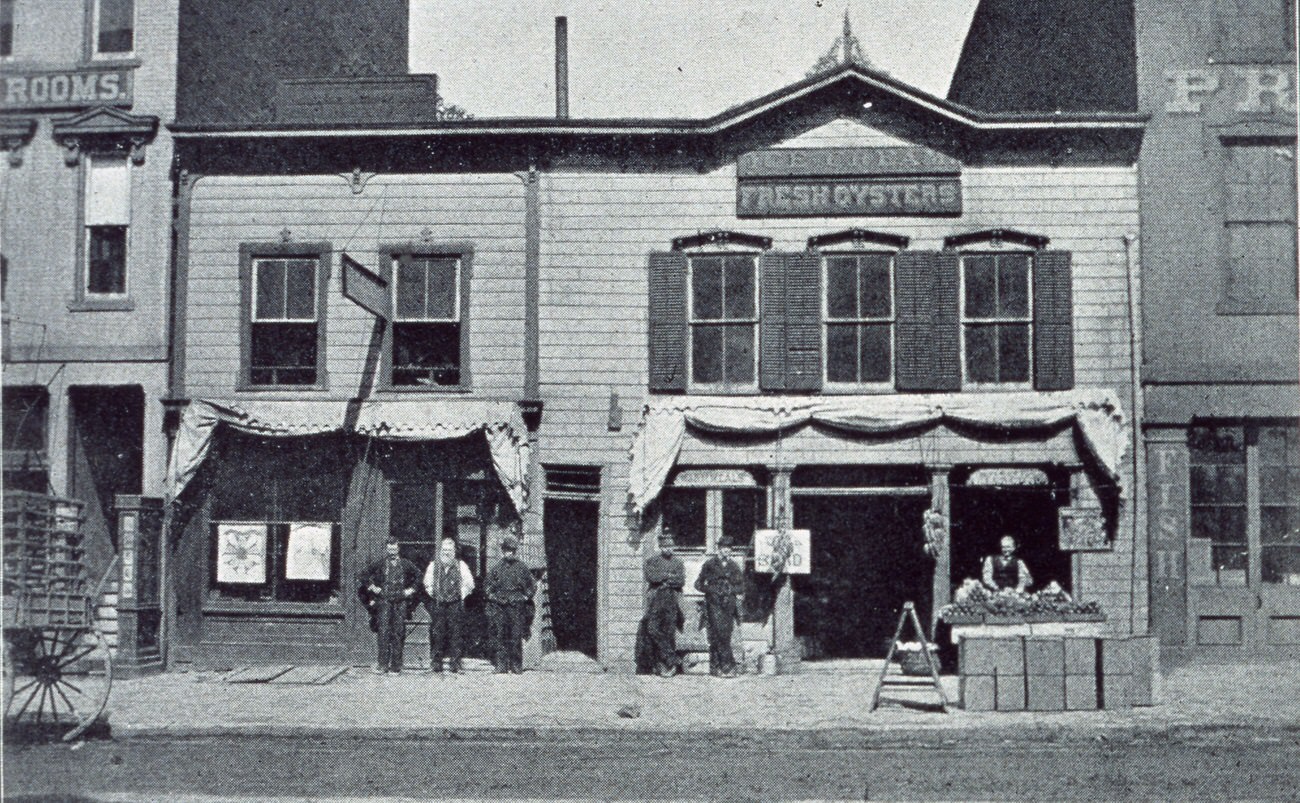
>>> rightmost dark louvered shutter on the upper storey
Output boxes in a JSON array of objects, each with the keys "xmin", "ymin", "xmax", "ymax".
[{"xmin": 1034, "ymin": 251, "xmax": 1074, "ymax": 390}]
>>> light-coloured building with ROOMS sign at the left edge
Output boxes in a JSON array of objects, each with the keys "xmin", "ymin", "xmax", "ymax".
[{"xmin": 0, "ymin": 0, "xmax": 177, "ymax": 662}]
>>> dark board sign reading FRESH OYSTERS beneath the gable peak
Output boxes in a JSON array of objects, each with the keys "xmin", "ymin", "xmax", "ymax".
[{"xmin": 736, "ymin": 147, "xmax": 962, "ymax": 217}]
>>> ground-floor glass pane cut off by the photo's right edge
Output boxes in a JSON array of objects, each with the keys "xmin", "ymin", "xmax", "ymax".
[{"xmin": 1260, "ymin": 426, "xmax": 1300, "ymax": 586}]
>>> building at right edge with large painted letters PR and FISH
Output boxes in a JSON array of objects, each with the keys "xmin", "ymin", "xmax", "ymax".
[{"xmin": 1136, "ymin": 0, "xmax": 1300, "ymax": 660}]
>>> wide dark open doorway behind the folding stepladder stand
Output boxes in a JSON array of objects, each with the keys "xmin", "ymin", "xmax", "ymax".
[{"xmin": 793, "ymin": 495, "xmax": 935, "ymax": 660}]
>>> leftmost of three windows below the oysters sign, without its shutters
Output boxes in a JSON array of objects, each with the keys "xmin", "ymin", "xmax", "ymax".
[{"xmin": 688, "ymin": 253, "xmax": 758, "ymax": 391}]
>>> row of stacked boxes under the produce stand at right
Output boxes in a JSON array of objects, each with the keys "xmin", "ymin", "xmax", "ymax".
[{"xmin": 959, "ymin": 637, "xmax": 1160, "ymax": 711}]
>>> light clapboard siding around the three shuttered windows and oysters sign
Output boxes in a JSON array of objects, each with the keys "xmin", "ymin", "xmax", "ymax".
[{"xmin": 540, "ymin": 123, "xmax": 1138, "ymax": 664}]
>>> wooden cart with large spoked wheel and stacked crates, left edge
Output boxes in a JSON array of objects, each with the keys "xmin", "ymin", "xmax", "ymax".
[{"xmin": 4, "ymin": 491, "xmax": 113, "ymax": 742}]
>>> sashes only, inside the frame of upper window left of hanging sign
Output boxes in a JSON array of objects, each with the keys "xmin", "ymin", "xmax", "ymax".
[{"xmin": 248, "ymin": 257, "xmax": 320, "ymax": 385}]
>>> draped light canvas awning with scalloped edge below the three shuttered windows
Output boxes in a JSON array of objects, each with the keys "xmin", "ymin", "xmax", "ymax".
[{"xmin": 628, "ymin": 391, "xmax": 1125, "ymax": 512}]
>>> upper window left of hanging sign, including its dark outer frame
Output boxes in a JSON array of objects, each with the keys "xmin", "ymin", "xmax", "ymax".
[{"xmin": 241, "ymin": 243, "xmax": 329, "ymax": 389}]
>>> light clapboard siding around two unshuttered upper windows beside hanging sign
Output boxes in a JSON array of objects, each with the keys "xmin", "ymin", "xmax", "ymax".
[{"xmin": 185, "ymin": 174, "xmax": 524, "ymax": 398}]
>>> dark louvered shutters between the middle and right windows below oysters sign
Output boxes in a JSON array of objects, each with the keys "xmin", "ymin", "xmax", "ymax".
[{"xmin": 894, "ymin": 251, "xmax": 962, "ymax": 391}]
